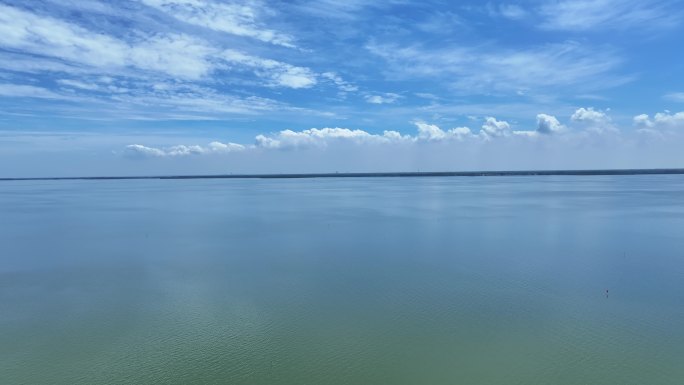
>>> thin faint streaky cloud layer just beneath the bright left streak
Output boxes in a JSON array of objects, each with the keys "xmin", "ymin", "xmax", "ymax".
[{"xmin": 0, "ymin": 76, "xmax": 296, "ymax": 120}]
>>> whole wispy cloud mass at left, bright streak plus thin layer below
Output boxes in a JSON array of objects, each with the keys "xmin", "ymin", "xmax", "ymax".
[{"xmin": 0, "ymin": 2, "xmax": 352, "ymax": 118}]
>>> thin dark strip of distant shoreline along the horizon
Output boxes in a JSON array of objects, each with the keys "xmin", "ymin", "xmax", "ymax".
[{"xmin": 0, "ymin": 168, "xmax": 684, "ymax": 182}]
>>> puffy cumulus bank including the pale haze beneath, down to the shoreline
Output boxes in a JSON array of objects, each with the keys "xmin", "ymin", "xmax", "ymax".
[{"xmin": 109, "ymin": 108, "xmax": 684, "ymax": 172}]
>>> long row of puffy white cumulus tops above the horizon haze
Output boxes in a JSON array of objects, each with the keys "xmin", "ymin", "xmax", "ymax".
[{"xmin": 123, "ymin": 107, "xmax": 684, "ymax": 157}]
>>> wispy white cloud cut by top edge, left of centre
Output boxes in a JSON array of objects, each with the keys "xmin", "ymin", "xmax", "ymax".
[{"xmin": 142, "ymin": 0, "xmax": 295, "ymax": 48}]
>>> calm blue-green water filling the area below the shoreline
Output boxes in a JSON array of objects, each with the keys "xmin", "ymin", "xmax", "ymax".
[{"xmin": 0, "ymin": 176, "xmax": 684, "ymax": 385}]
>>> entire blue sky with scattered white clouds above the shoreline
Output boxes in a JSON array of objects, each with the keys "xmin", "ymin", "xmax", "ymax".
[{"xmin": 0, "ymin": 0, "xmax": 684, "ymax": 177}]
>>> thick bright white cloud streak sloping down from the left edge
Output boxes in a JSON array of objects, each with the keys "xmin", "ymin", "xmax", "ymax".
[{"xmin": 0, "ymin": 5, "xmax": 316, "ymax": 88}]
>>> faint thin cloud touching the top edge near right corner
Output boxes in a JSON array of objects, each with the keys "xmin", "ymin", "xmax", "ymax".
[{"xmin": 538, "ymin": 0, "xmax": 681, "ymax": 31}]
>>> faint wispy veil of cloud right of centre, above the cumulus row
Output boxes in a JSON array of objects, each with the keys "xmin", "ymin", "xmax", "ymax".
[{"xmin": 367, "ymin": 41, "xmax": 631, "ymax": 94}]
